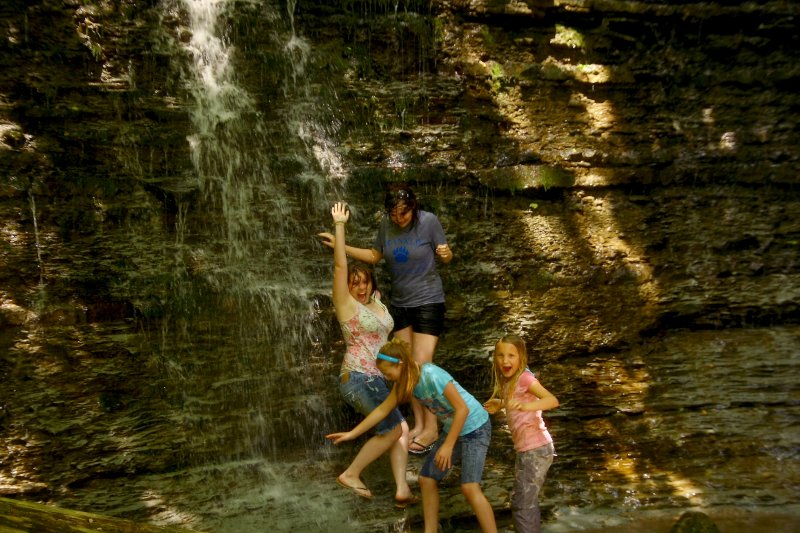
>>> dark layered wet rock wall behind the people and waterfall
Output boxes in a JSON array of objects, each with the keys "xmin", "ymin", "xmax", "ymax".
[{"xmin": 0, "ymin": 0, "xmax": 800, "ymax": 529}]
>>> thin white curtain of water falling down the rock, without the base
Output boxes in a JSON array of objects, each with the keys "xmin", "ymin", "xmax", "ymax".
[{"xmin": 153, "ymin": 0, "xmax": 342, "ymax": 464}]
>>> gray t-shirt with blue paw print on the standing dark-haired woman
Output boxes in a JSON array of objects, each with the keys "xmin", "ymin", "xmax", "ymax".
[{"xmin": 373, "ymin": 211, "xmax": 447, "ymax": 307}]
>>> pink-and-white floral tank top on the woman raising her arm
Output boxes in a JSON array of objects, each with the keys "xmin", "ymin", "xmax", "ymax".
[{"xmin": 339, "ymin": 300, "xmax": 394, "ymax": 376}]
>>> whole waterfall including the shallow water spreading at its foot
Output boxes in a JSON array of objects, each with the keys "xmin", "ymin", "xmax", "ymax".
[{"xmin": 93, "ymin": 0, "xmax": 372, "ymax": 532}]
